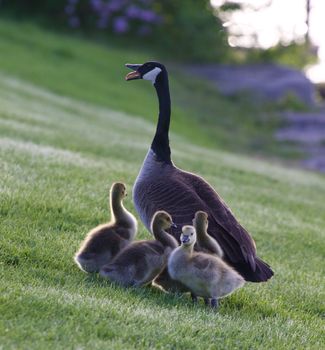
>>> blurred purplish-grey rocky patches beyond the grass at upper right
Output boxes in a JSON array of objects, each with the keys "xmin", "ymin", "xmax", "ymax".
[{"xmin": 186, "ymin": 64, "xmax": 325, "ymax": 173}]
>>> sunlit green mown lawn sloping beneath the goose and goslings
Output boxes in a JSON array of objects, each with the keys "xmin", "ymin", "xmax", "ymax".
[{"xmin": 0, "ymin": 19, "xmax": 325, "ymax": 349}]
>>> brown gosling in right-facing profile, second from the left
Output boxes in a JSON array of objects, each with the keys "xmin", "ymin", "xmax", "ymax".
[{"xmin": 100, "ymin": 211, "xmax": 178, "ymax": 287}]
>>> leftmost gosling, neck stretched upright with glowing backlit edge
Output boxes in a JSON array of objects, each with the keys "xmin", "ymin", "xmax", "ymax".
[{"xmin": 75, "ymin": 182, "xmax": 137, "ymax": 272}]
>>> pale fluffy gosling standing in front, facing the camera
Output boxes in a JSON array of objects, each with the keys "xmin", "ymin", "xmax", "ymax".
[{"xmin": 168, "ymin": 225, "xmax": 245, "ymax": 307}]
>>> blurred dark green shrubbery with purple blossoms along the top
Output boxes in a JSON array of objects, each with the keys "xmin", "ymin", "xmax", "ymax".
[{"xmin": 2, "ymin": 0, "xmax": 228, "ymax": 61}]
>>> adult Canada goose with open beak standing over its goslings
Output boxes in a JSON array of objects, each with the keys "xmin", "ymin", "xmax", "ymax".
[{"xmin": 125, "ymin": 62, "xmax": 273, "ymax": 282}]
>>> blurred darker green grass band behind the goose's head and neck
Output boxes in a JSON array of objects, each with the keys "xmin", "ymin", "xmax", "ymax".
[{"xmin": 0, "ymin": 21, "xmax": 286, "ymax": 154}]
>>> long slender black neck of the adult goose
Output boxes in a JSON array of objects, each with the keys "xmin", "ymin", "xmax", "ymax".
[{"xmin": 151, "ymin": 70, "xmax": 171, "ymax": 163}]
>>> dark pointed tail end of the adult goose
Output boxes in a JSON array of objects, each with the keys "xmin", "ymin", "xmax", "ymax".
[{"xmin": 232, "ymin": 257, "xmax": 274, "ymax": 282}]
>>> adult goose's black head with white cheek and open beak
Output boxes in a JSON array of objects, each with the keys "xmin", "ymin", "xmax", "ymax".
[{"xmin": 125, "ymin": 62, "xmax": 166, "ymax": 84}]
